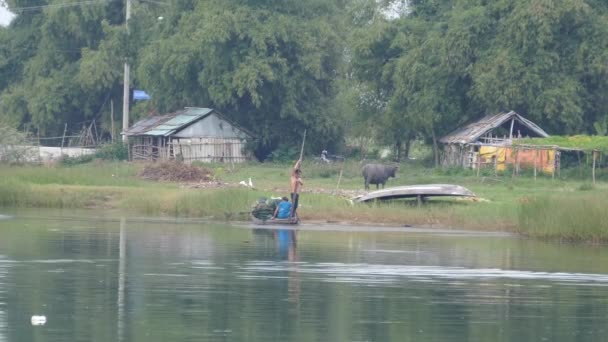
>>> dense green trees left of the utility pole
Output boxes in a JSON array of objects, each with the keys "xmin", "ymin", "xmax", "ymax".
[{"xmin": 0, "ymin": 0, "xmax": 123, "ymax": 137}]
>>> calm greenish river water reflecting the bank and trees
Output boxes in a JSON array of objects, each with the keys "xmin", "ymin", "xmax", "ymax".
[{"xmin": 0, "ymin": 210, "xmax": 608, "ymax": 342}]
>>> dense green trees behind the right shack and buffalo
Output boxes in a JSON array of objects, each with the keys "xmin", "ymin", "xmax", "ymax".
[{"xmin": 353, "ymin": 0, "xmax": 608, "ymax": 164}]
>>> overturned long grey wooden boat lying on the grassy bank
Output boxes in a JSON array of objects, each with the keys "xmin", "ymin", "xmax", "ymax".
[{"xmin": 353, "ymin": 184, "xmax": 476, "ymax": 203}]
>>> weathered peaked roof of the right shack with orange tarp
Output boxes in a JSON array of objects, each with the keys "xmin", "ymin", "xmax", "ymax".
[{"xmin": 439, "ymin": 111, "xmax": 549, "ymax": 144}]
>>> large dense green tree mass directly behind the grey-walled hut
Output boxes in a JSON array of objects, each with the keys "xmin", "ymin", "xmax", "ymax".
[{"xmin": 137, "ymin": 0, "xmax": 342, "ymax": 158}]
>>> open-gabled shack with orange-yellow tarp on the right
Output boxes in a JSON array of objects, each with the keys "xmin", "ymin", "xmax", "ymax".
[{"xmin": 439, "ymin": 111, "xmax": 555, "ymax": 169}]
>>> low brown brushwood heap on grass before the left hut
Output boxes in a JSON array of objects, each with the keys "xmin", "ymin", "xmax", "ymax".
[{"xmin": 139, "ymin": 162, "xmax": 213, "ymax": 182}]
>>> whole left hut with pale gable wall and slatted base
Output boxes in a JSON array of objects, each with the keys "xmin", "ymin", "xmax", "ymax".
[{"xmin": 122, "ymin": 107, "xmax": 252, "ymax": 163}]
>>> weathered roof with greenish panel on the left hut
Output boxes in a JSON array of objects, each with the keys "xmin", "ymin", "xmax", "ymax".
[{"xmin": 123, "ymin": 107, "xmax": 213, "ymax": 136}]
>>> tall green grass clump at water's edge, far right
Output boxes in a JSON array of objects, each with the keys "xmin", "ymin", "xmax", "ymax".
[{"xmin": 519, "ymin": 194, "xmax": 608, "ymax": 242}]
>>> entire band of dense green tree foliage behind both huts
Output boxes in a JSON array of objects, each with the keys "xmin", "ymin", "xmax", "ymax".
[{"xmin": 0, "ymin": 0, "xmax": 608, "ymax": 158}]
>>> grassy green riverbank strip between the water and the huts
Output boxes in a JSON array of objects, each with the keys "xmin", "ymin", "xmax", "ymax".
[{"xmin": 0, "ymin": 162, "xmax": 608, "ymax": 242}]
